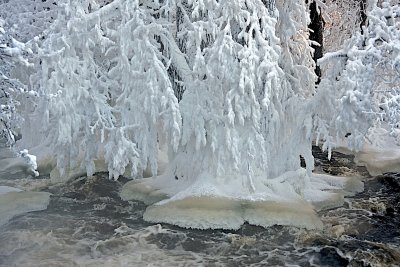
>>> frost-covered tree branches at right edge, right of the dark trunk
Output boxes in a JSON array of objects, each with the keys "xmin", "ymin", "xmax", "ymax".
[{"xmin": 316, "ymin": 1, "xmax": 400, "ymax": 148}]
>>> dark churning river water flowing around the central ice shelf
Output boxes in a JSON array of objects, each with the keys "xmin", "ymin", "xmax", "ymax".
[{"xmin": 0, "ymin": 148, "xmax": 400, "ymax": 266}]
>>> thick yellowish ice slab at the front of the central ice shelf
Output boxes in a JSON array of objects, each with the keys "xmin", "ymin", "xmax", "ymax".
[{"xmin": 143, "ymin": 196, "xmax": 322, "ymax": 230}]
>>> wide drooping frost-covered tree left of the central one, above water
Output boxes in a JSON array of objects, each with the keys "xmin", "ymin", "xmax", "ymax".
[{"xmin": 21, "ymin": 1, "xmax": 181, "ymax": 179}]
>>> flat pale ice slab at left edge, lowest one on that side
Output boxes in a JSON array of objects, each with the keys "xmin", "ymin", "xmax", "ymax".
[{"xmin": 0, "ymin": 192, "xmax": 51, "ymax": 226}]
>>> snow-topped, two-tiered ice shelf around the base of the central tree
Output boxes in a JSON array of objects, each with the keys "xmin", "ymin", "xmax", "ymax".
[{"xmin": 121, "ymin": 170, "xmax": 363, "ymax": 229}]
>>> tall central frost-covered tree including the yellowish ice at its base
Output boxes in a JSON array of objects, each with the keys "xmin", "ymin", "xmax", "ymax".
[{"xmin": 131, "ymin": 1, "xmax": 334, "ymax": 228}]
